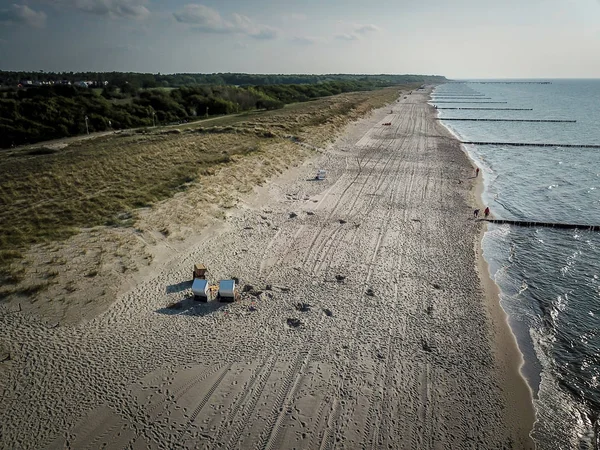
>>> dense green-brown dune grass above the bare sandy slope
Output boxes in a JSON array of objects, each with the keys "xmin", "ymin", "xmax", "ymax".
[{"xmin": 0, "ymin": 88, "xmax": 408, "ymax": 288}]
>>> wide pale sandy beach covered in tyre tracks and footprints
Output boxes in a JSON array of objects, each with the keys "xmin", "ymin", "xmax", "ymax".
[{"xmin": 0, "ymin": 90, "xmax": 534, "ymax": 449}]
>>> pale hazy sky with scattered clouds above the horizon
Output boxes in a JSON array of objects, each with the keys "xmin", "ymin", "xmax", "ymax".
[{"xmin": 0, "ymin": 0, "xmax": 600, "ymax": 79}]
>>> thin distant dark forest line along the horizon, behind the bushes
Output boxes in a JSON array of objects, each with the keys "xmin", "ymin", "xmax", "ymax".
[{"xmin": 0, "ymin": 71, "xmax": 446, "ymax": 89}]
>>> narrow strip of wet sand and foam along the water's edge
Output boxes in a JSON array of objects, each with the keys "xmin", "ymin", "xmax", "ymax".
[{"xmin": 436, "ymin": 94, "xmax": 537, "ymax": 448}]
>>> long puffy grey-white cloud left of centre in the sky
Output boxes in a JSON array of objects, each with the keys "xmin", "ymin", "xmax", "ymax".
[{"xmin": 173, "ymin": 4, "xmax": 279, "ymax": 39}]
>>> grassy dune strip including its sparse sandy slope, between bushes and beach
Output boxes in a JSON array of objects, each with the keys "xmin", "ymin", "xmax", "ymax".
[{"xmin": 0, "ymin": 83, "xmax": 412, "ymax": 321}]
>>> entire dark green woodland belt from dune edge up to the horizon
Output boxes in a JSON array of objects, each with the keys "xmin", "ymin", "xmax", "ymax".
[{"xmin": 0, "ymin": 71, "xmax": 446, "ymax": 148}]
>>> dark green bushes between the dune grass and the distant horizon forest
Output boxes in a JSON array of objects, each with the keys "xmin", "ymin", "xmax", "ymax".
[{"xmin": 0, "ymin": 81, "xmax": 398, "ymax": 148}]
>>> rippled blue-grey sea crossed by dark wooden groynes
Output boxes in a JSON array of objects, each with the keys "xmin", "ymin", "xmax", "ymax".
[{"xmin": 431, "ymin": 79, "xmax": 600, "ymax": 450}]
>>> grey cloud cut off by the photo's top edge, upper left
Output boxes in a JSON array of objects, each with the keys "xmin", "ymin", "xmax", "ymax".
[{"xmin": 52, "ymin": 0, "xmax": 150, "ymax": 19}]
